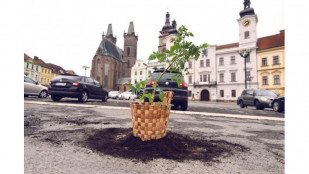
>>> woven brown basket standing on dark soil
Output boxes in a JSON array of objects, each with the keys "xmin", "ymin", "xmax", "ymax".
[{"xmin": 130, "ymin": 91, "xmax": 173, "ymax": 141}]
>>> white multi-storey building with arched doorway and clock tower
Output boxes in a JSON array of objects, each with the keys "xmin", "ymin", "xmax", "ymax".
[{"xmin": 185, "ymin": 4, "xmax": 258, "ymax": 101}]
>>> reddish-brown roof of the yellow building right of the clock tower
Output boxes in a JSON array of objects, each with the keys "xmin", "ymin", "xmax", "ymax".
[{"xmin": 257, "ymin": 30, "xmax": 285, "ymax": 50}]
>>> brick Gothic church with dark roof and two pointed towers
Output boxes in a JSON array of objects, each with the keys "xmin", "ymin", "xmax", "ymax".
[{"xmin": 90, "ymin": 22, "xmax": 138, "ymax": 91}]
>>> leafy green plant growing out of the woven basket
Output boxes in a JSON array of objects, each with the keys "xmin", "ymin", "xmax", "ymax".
[{"xmin": 130, "ymin": 26, "xmax": 208, "ymax": 105}]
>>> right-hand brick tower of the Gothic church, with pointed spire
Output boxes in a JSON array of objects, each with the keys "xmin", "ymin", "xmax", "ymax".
[{"xmin": 123, "ymin": 22, "xmax": 138, "ymax": 77}]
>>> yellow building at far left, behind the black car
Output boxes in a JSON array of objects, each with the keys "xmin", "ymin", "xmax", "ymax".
[{"xmin": 34, "ymin": 56, "xmax": 52, "ymax": 86}]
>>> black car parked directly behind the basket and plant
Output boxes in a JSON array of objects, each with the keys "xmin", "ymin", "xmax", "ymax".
[{"xmin": 145, "ymin": 69, "xmax": 188, "ymax": 111}]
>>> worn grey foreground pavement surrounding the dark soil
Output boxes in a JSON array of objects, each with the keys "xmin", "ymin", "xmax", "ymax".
[{"xmin": 24, "ymin": 103, "xmax": 285, "ymax": 174}]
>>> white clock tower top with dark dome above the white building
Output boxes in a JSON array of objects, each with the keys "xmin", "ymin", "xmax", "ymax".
[{"xmin": 238, "ymin": 0, "xmax": 258, "ymax": 48}]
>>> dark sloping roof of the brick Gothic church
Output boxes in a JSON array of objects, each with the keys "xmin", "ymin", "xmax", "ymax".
[{"xmin": 99, "ymin": 37, "xmax": 124, "ymax": 62}]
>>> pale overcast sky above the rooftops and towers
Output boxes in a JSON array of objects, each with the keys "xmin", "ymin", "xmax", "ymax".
[{"xmin": 22, "ymin": 0, "xmax": 285, "ymax": 75}]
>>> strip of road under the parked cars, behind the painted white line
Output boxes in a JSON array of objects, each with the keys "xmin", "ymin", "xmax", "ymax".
[{"xmin": 25, "ymin": 97, "xmax": 285, "ymax": 118}]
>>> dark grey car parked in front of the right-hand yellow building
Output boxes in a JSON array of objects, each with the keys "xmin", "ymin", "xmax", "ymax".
[{"xmin": 237, "ymin": 89, "xmax": 277, "ymax": 109}]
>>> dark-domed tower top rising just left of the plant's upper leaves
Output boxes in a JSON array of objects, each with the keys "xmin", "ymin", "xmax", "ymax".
[{"xmin": 158, "ymin": 12, "xmax": 177, "ymax": 52}]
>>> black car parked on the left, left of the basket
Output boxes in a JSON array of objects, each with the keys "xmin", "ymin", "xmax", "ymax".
[{"xmin": 48, "ymin": 75, "xmax": 108, "ymax": 102}]
